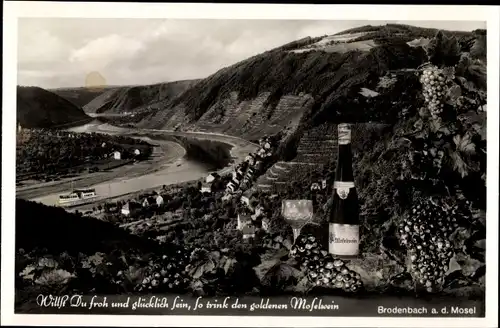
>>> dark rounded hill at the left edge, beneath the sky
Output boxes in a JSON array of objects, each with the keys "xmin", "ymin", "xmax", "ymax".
[{"xmin": 17, "ymin": 86, "xmax": 91, "ymax": 128}]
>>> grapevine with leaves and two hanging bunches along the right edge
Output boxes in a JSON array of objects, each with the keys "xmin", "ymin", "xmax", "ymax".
[{"xmin": 396, "ymin": 33, "xmax": 486, "ymax": 292}]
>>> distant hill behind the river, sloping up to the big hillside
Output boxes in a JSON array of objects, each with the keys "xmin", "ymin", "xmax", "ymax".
[{"xmin": 83, "ymin": 80, "xmax": 197, "ymax": 114}]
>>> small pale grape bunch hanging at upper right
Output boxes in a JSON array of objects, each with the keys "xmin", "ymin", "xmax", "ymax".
[{"xmin": 420, "ymin": 66, "xmax": 447, "ymax": 118}]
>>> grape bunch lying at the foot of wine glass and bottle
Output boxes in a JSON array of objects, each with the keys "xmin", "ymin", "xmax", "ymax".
[{"xmin": 290, "ymin": 235, "xmax": 363, "ymax": 292}]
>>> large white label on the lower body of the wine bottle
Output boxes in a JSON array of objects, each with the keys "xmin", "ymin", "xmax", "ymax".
[{"xmin": 328, "ymin": 223, "xmax": 359, "ymax": 256}]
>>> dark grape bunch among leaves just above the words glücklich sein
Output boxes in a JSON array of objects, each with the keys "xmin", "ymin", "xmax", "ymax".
[{"xmin": 126, "ymin": 249, "xmax": 191, "ymax": 292}]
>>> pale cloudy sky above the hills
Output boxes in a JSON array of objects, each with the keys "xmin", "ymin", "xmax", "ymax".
[{"xmin": 17, "ymin": 18, "xmax": 486, "ymax": 89}]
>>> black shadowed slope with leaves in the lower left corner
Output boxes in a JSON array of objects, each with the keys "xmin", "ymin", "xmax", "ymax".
[{"xmin": 15, "ymin": 199, "xmax": 161, "ymax": 302}]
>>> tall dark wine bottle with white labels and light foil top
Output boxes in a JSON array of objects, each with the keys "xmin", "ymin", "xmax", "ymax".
[{"xmin": 328, "ymin": 124, "xmax": 360, "ymax": 258}]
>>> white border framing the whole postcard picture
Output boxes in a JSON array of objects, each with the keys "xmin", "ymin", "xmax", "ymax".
[{"xmin": 1, "ymin": 1, "xmax": 500, "ymax": 327}]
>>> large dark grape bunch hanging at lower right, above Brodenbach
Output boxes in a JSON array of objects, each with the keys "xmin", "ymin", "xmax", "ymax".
[{"xmin": 399, "ymin": 199, "xmax": 458, "ymax": 292}]
